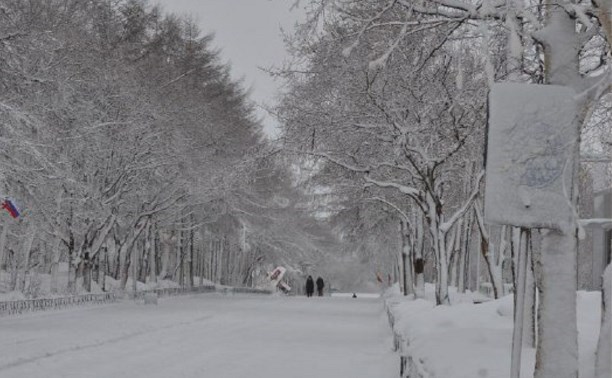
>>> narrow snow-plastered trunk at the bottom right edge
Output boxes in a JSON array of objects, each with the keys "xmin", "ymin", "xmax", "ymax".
[{"xmin": 595, "ymin": 264, "xmax": 612, "ymax": 378}]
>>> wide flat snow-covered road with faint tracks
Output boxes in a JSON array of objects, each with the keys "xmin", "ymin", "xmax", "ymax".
[{"xmin": 0, "ymin": 294, "xmax": 399, "ymax": 378}]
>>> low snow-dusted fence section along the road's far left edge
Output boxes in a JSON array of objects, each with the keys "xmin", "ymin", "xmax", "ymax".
[{"xmin": 0, "ymin": 293, "xmax": 117, "ymax": 316}]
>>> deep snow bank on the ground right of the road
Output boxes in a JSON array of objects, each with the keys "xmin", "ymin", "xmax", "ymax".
[{"xmin": 386, "ymin": 285, "xmax": 601, "ymax": 378}]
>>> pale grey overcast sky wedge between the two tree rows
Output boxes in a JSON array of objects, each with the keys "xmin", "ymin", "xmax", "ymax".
[{"xmin": 150, "ymin": 0, "xmax": 300, "ymax": 136}]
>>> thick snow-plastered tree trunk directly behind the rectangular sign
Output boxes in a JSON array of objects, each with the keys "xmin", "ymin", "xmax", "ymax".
[{"xmin": 534, "ymin": 0, "xmax": 584, "ymax": 378}]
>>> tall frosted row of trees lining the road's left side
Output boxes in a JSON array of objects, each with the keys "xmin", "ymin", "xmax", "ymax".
[{"xmin": 0, "ymin": 0, "xmax": 340, "ymax": 294}]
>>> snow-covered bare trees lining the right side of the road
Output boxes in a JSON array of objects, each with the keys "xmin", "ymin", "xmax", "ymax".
[{"xmin": 279, "ymin": 0, "xmax": 612, "ymax": 377}]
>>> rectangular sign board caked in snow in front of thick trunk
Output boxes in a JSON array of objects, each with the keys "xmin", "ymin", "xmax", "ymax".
[{"xmin": 485, "ymin": 83, "xmax": 578, "ymax": 231}]
